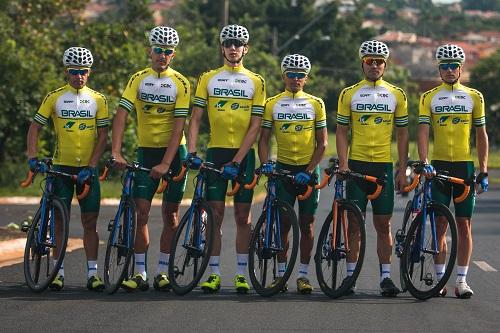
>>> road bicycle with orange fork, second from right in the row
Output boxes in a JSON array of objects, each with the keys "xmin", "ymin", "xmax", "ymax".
[{"xmin": 314, "ymin": 159, "xmax": 387, "ymax": 298}]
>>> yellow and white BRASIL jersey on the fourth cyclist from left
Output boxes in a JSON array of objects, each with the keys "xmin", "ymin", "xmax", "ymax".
[{"xmin": 262, "ymin": 90, "xmax": 326, "ymax": 165}]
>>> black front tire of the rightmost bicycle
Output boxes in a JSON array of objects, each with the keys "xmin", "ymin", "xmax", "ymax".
[{"xmin": 401, "ymin": 201, "xmax": 457, "ymax": 300}]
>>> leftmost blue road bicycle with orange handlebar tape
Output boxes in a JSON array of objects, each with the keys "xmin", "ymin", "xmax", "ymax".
[{"xmin": 21, "ymin": 158, "xmax": 90, "ymax": 292}]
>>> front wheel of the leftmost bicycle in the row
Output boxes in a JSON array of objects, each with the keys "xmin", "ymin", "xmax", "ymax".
[{"xmin": 24, "ymin": 198, "xmax": 69, "ymax": 292}]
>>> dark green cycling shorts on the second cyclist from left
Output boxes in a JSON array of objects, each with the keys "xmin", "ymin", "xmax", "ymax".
[{"xmin": 133, "ymin": 145, "xmax": 187, "ymax": 203}]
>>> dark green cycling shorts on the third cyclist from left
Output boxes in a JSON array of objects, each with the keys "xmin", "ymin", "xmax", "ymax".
[{"xmin": 205, "ymin": 148, "xmax": 255, "ymax": 203}]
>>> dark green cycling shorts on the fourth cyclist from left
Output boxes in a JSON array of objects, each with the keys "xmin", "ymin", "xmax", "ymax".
[{"xmin": 276, "ymin": 162, "xmax": 319, "ymax": 215}]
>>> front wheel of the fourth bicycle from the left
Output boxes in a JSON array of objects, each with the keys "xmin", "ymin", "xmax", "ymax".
[{"xmin": 248, "ymin": 200, "xmax": 299, "ymax": 296}]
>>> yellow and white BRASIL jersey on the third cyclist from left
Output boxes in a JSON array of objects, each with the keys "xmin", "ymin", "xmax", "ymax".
[{"xmin": 194, "ymin": 65, "xmax": 266, "ymax": 148}]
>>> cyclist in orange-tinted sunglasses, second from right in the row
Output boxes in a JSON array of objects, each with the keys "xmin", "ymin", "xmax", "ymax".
[{"xmin": 336, "ymin": 40, "xmax": 408, "ymax": 296}]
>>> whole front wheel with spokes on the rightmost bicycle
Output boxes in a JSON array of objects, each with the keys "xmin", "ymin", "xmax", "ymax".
[{"xmin": 401, "ymin": 201, "xmax": 457, "ymax": 300}]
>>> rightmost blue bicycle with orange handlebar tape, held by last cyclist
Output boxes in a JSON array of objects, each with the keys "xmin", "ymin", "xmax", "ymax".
[{"xmin": 395, "ymin": 162, "xmax": 472, "ymax": 300}]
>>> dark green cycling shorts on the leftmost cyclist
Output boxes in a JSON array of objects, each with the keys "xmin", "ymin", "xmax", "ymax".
[{"xmin": 54, "ymin": 165, "xmax": 101, "ymax": 213}]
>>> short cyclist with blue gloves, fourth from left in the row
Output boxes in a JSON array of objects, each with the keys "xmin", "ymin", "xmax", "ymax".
[{"xmin": 259, "ymin": 54, "xmax": 328, "ymax": 294}]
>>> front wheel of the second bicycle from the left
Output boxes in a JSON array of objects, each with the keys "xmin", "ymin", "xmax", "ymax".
[{"xmin": 104, "ymin": 198, "xmax": 136, "ymax": 294}]
